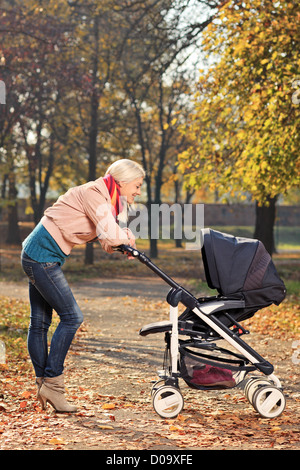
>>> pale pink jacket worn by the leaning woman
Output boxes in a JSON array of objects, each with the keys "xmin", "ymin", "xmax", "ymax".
[{"xmin": 41, "ymin": 178, "xmax": 131, "ymax": 255}]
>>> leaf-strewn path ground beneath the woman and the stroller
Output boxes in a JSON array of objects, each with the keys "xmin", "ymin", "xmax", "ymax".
[{"xmin": 0, "ymin": 278, "xmax": 300, "ymax": 452}]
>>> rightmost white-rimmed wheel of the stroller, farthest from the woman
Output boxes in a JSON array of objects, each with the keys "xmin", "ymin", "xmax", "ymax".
[{"xmin": 252, "ymin": 385, "xmax": 285, "ymax": 418}]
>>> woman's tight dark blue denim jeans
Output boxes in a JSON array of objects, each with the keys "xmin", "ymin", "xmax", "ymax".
[{"xmin": 21, "ymin": 251, "xmax": 83, "ymax": 377}]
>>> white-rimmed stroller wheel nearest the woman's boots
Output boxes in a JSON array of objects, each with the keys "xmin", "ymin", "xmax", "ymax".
[{"xmin": 152, "ymin": 385, "xmax": 183, "ymax": 418}]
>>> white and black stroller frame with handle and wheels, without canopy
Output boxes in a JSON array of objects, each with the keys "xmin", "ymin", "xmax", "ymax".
[{"xmin": 117, "ymin": 241, "xmax": 285, "ymax": 418}]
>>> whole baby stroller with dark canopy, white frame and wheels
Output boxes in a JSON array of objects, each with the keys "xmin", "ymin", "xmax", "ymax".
[{"xmin": 118, "ymin": 228, "xmax": 286, "ymax": 418}]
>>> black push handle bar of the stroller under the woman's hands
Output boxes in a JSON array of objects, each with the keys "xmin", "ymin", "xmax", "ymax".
[{"xmin": 115, "ymin": 245, "xmax": 198, "ymax": 308}]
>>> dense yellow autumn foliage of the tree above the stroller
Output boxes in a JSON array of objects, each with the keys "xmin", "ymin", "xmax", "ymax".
[{"xmin": 179, "ymin": 0, "xmax": 300, "ymax": 202}]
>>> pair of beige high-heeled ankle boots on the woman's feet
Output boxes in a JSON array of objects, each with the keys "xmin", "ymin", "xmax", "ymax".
[{"xmin": 39, "ymin": 374, "xmax": 77, "ymax": 413}]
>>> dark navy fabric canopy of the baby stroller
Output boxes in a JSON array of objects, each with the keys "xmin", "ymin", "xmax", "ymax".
[{"xmin": 201, "ymin": 228, "xmax": 286, "ymax": 309}]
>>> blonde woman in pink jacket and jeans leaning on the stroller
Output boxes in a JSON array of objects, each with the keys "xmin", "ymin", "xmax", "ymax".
[{"xmin": 21, "ymin": 159, "xmax": 145, "ymax": 413}]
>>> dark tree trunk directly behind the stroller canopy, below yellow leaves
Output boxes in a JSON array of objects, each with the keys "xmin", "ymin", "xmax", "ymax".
[{"xmin": 254, "ymin": 196, "xmax": 277, "ymax": 256}]
